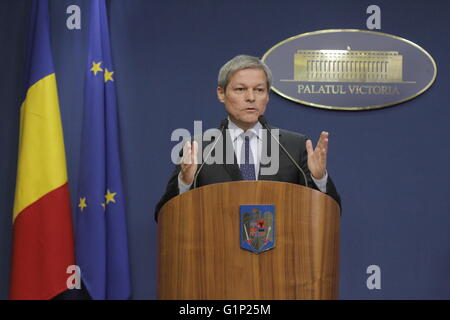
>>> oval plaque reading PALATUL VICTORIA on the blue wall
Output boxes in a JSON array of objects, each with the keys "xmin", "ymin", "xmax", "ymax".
[{"xmin": 262, "ymin": 29, "xmax": 437, "ymax": 110}]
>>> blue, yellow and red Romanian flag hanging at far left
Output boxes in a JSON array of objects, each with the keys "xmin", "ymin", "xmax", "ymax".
[{"xmin": 10, "ymin": 0, "xmax": 75, "ymax": 299}]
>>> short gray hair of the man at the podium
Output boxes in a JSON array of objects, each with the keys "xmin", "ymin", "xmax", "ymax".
[{"xmin": 218, "ymin": 55, "xmax": 272, "ymax": 91}]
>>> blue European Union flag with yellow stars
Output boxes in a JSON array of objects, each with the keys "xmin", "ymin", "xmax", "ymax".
[{"xmin": 76, "ymin": 0, "xmax": 131, "ymax": 299}]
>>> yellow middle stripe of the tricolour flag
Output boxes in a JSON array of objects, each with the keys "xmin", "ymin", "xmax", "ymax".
[{"xmin": 13, "ymin": 73, "xmax": 67, "ymax": 221}]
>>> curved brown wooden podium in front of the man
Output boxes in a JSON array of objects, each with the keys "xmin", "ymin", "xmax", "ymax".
[{"xmin": 158, "ymin": 181, "xmax": 340, "ymax": 300}]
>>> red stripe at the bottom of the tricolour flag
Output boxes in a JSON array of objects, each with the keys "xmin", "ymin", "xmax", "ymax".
[{"xmin": 10, "ymin": 183, "xmax": 75, "ymax": 300}]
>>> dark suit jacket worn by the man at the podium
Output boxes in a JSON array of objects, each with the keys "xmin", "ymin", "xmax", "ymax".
[{"xmin": 155, "ymin": 121, "xmax": 341, "ymax": 220}]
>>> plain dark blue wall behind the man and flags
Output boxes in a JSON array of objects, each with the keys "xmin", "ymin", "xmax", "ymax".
[{"xmin": 0, "ymin": 0, "xmax": 450, "ymax": 299}]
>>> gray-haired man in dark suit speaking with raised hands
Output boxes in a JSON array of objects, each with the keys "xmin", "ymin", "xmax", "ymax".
[{"xmin": 155, "ymin": 55, "xmax": 340, "ymax": 219}]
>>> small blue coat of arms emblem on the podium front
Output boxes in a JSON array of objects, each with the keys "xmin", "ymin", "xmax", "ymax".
[{"xmin": 240, "ymin": 205, "xmax": 275, "ymax": 253}]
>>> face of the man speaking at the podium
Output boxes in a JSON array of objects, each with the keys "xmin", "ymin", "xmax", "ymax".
[{"xmin": 217, "ymin": 68, "xmax": 269, "ymax": 130}]
